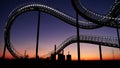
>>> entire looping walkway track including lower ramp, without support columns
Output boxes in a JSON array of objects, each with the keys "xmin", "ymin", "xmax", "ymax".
[{"xmin": 4, "ymin": 0, "xmax": 120, "ymax": 58}]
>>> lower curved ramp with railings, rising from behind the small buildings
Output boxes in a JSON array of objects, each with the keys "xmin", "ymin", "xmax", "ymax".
[{"xmin": 42, "ymin": 35, "xmax": 120, "ymax": 58}]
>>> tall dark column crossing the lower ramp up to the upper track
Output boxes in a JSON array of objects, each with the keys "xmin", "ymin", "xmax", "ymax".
[{"xmin": 76, "ymin": 12, "xmax": 80, "ymax": 61}]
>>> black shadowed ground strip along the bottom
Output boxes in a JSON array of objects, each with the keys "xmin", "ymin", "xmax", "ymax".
[{"xmin": 0, "ymin": 59, "xmax": 120, "ymax": 67}]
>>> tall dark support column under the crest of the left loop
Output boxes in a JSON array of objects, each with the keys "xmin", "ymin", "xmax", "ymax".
[{"xmin": 36, "ymin": 12, "xmax": 40, "ymax": 59}]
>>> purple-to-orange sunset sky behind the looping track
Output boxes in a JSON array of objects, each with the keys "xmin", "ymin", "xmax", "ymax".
[{"xmin": 0, "ymin": 0, "xmax": 120, "ymax": 60}]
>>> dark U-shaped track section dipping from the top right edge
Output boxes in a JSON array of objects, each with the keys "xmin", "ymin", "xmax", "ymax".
[{"xmin": 72, "ymin": 0, "xmax": 120, "ymax": 28}]
